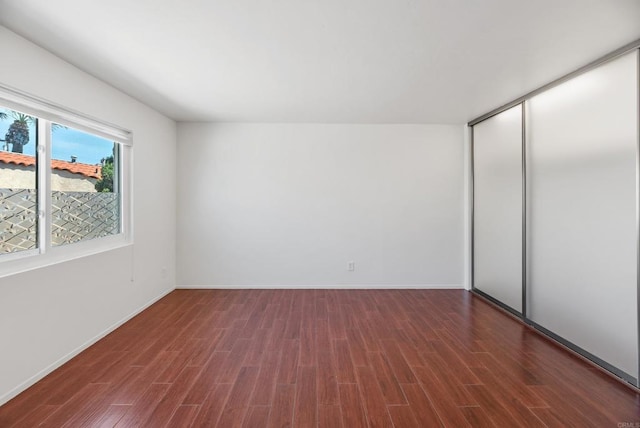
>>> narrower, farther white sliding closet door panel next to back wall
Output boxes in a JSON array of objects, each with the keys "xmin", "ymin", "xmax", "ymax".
[{"xmin": 473, "ymin": 105, "xmax": 522, "ymax": 312}]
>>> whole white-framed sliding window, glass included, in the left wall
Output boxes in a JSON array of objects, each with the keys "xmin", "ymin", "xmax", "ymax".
[{"xmin": 0, "ymin": 86, "xmax": 131, "ymax": 275}]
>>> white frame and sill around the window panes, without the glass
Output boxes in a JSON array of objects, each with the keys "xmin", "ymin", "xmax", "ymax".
[{"xmin": 0, "ymin": 83, "xmax": 133, "ymax": 278}]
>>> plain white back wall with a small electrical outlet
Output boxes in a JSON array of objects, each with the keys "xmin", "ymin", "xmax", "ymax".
[{"xmin": 177, "ymin": 123, "xmax": 464, "ymax": 287}]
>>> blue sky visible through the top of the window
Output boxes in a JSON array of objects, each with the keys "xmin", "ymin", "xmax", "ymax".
[{"xmin": 0, "ymin": 109, "xmax": 113, "ymax": 164}]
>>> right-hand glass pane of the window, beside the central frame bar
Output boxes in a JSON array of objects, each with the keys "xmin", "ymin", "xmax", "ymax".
[{"xmin": 51, "ymin": 124, "xmax": 120, "ymax": 246}]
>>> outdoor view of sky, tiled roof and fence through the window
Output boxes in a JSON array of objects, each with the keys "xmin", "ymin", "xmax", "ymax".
[{"xmin": 0, "ymin": 108, "xmax": 121, "ymax": 254}]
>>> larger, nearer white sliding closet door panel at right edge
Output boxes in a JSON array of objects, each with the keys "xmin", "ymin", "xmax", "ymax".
[{"xmin": 528, "ymin": 50, "xmax": 638, "ymax": 378}]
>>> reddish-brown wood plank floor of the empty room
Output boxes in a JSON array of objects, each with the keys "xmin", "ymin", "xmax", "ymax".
[{"xmin": 0, "ymin": 290, "xmax": 640, "ymax": 428}]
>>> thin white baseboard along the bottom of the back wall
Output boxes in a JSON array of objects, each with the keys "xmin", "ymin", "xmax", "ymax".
[{"xmin": 176, "ymin": 284, "xmax": 464, "ymax": 290}]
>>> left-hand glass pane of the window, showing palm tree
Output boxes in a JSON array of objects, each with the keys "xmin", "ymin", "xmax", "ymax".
[{"xmin": 0, "ymin": 107, "xmax": 38, "ymax": 254}]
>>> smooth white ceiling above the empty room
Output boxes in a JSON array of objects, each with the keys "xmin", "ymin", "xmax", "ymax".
[{"xmin": 0, "ymin": 0, "xmax": 640, "ymax": 123}]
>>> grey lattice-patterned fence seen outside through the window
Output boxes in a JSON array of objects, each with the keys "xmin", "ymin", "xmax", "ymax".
[{"xmin": 0, "ymin": 189, "xmax": 120, "ymax": 254}]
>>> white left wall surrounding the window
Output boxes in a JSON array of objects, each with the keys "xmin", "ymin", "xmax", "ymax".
[{"xmin": 0, "ymin": 27, "xmax": 176, "ymax": 404}]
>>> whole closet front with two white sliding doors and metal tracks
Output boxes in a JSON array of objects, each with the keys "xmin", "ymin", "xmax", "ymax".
[{"xmin": 469, "ymin": 48, "xmax": 640, "ymax": 385}]
